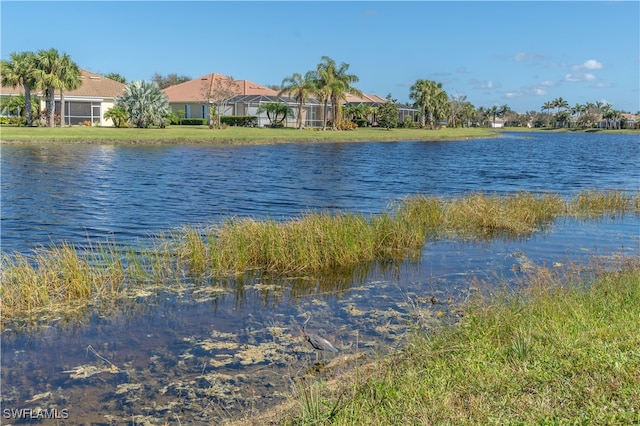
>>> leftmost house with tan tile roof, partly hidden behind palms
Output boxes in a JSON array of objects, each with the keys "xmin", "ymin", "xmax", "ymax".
[{"xmin": 0, "ymin": 69, "xmax": 125, "ymax": 126}]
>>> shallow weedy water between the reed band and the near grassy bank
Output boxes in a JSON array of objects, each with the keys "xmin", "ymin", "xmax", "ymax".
[{"xmin": 2, "ymin": 216, "xmax": 640, "ymax": 424}]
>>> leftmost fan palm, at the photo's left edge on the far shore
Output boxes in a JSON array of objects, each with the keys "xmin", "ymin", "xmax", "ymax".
[{"xmin": 0, "ymin": 52, "xmax": 37, "ymax": 126}]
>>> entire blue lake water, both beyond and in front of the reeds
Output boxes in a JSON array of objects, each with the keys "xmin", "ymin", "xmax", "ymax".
[{"xmin": 0, "ymin": 132, "xmax": 640, "ymax": 424}]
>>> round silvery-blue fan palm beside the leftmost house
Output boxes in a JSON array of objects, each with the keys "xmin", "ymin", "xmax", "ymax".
[{"xmin": 115, "ymin": 81, "xmax": 171, "ymax": 128}]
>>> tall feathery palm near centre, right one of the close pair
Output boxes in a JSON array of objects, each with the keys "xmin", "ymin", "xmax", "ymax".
[{"xmin": 318, "ymin": 56, "xmax": 362, "ymax": 130}]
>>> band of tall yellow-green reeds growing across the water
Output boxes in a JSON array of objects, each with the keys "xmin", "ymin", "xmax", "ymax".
[{"xmin": 0, "ymin": 191, "xmax": 640, "ymax": 324}]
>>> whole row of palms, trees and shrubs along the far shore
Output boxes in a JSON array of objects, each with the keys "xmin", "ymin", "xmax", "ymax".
[{"xmin": 0, "ymin": 48, "xmax": 626, "ymax": 130}]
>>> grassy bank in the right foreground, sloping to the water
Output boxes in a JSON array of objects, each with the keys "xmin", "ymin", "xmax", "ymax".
[{"xmin": 240, "ymin": 258, "xmax": 640, "ymax": 425}]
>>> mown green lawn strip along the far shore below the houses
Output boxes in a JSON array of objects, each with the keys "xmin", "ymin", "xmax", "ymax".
[{"xmin": 0, "ymin": 126, "xmax": 496, "ymax": 144}]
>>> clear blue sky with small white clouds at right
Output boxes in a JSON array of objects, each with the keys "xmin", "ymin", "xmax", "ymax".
[{"xmin": 0, "ymin": 0, "xmax": 640, "ymax": 112}]
